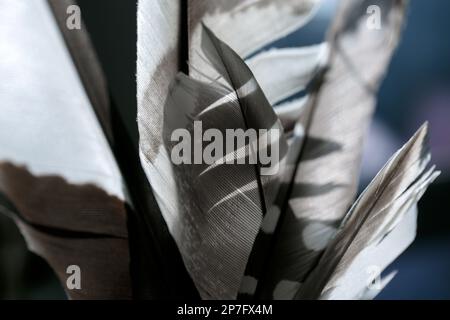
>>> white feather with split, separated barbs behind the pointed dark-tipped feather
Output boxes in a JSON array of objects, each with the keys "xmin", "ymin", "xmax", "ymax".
[{"xmin": 183, "ymin": 1, "xmax": 327, "ymax": 298}]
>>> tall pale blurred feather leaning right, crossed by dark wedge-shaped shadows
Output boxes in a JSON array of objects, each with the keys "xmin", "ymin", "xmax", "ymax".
[{"xmin": 253, "ymin": 0, "xmax": 412, "ymax": 298}]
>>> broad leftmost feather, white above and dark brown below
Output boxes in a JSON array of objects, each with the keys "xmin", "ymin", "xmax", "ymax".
[{"xmin": 0, "ymin": 0, "xmax": 131, "ymax": 299}]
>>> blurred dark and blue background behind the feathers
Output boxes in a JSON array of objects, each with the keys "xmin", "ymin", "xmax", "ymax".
[{"xmin": 0, "ymin": 0, "xmax": 450, "ymax": 299}]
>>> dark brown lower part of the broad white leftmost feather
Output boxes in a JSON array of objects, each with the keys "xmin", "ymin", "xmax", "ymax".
[{"xmin": 0, "ymin": 163, "xmax": 131, "ymax": 299}]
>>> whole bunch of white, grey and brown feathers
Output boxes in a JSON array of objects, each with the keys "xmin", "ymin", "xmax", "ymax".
[{"xmin": 0, "ymin": 0, "xmax": 439, "ymax": 299}]
